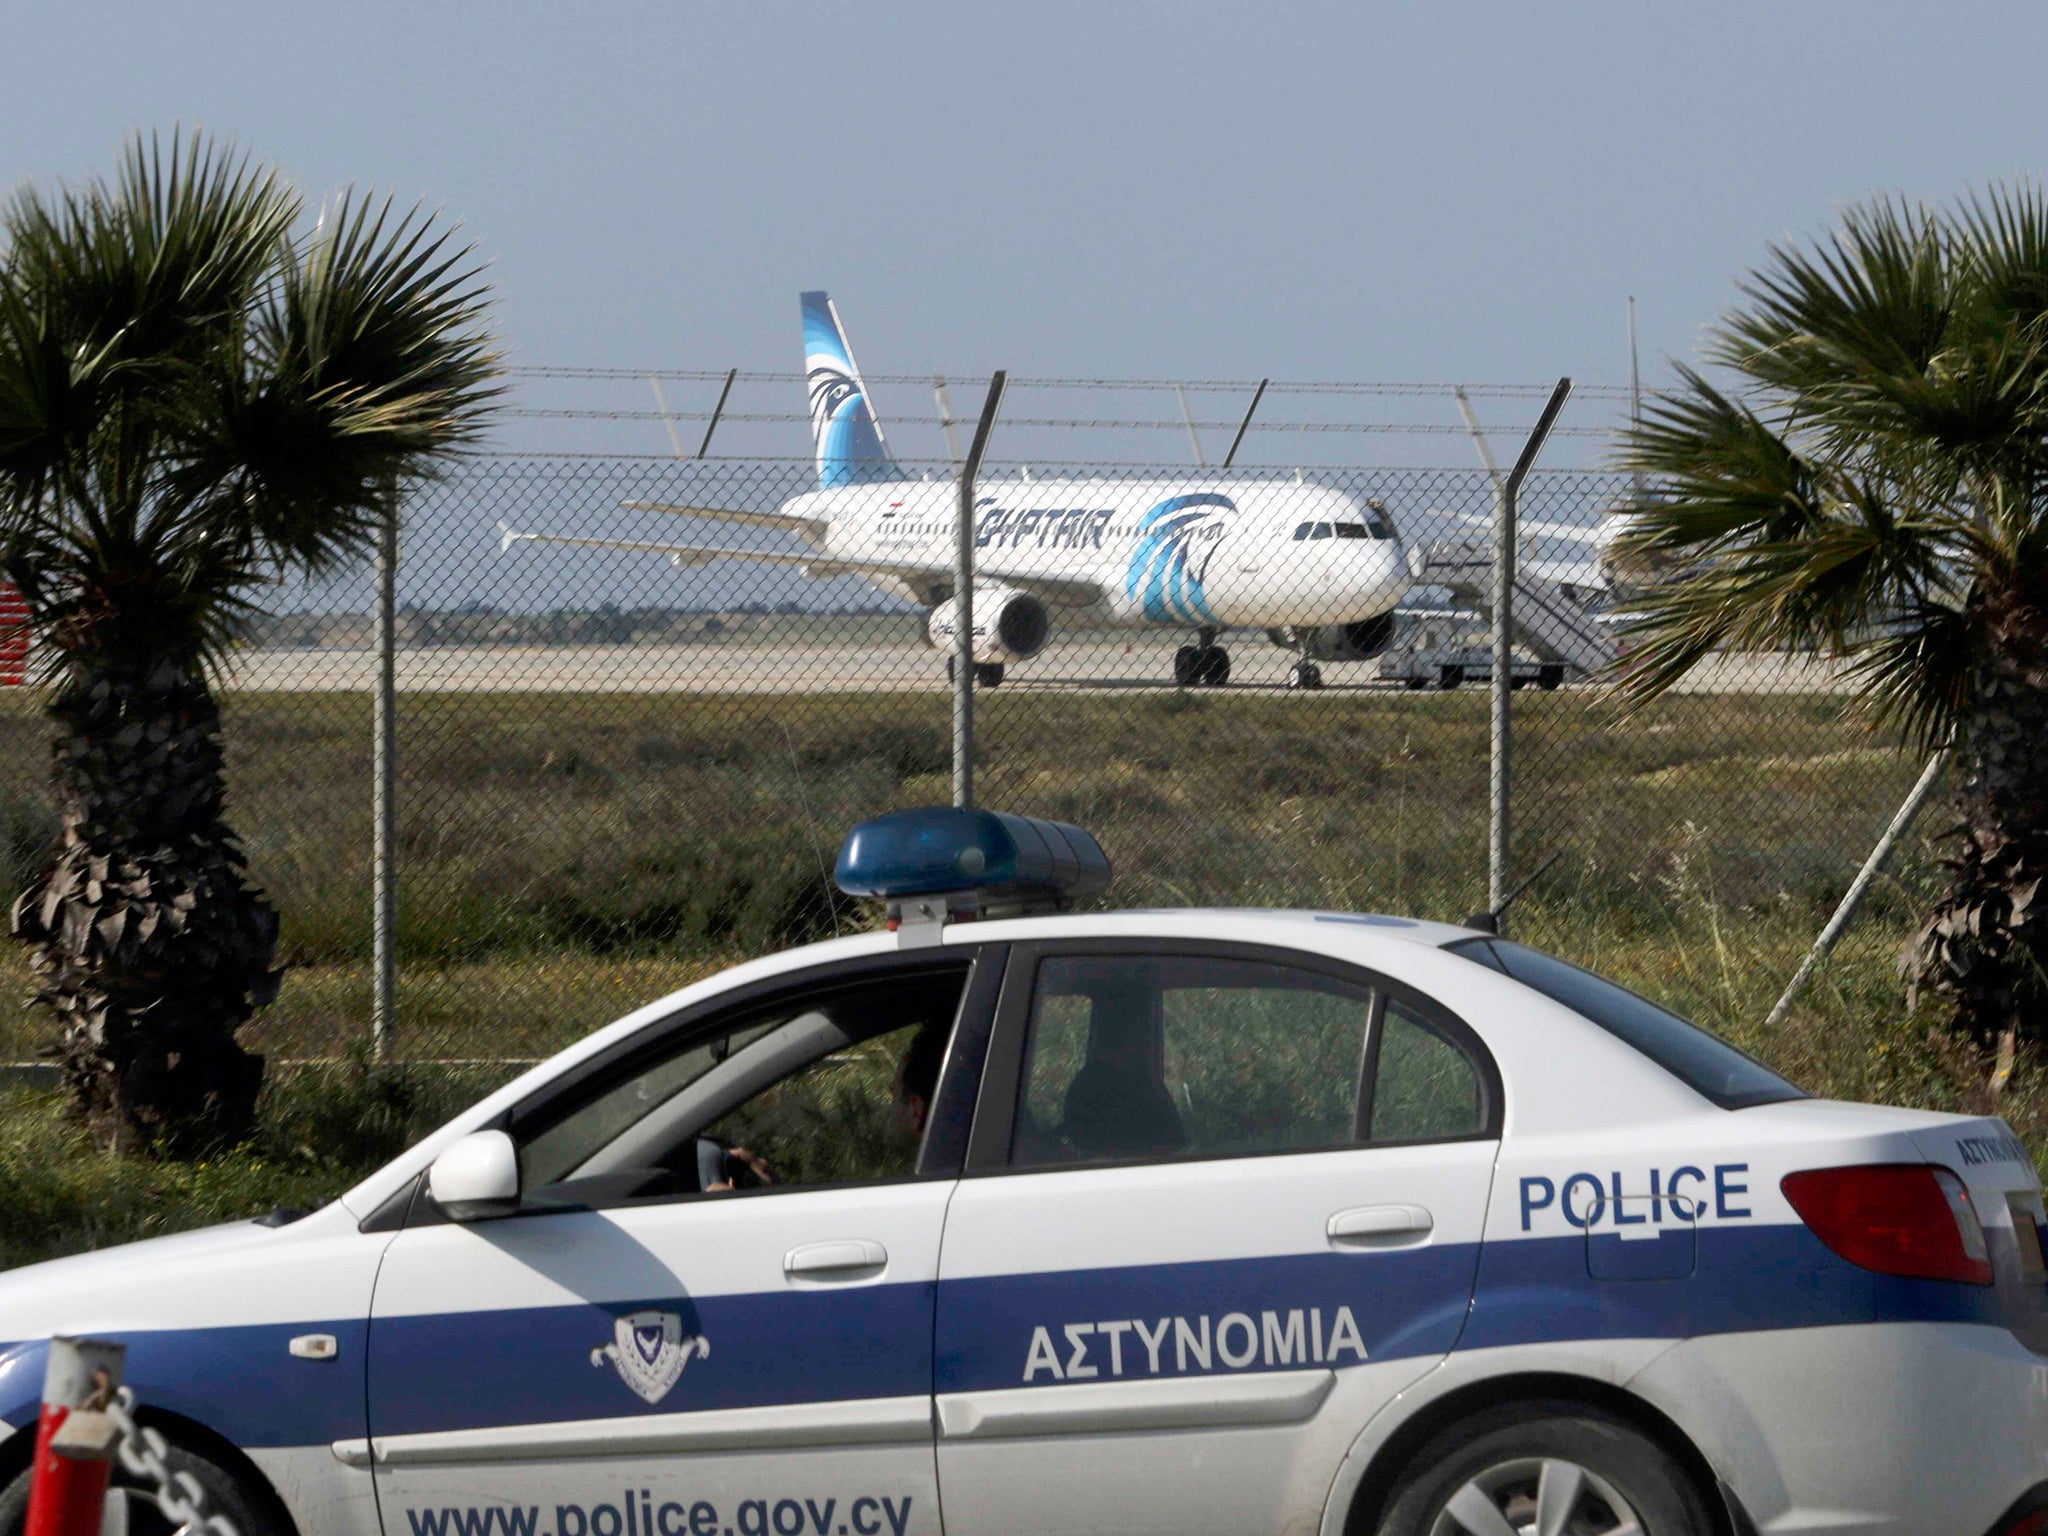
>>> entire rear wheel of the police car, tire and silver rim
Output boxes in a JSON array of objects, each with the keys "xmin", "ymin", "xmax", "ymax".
[{"xmin": 1380, "ymin": 1403, "xmax": 1714, "ymax": 1536}]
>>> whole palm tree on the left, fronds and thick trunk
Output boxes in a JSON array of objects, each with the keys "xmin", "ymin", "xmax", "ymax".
[{"xmin": 0, "ymin": 135, "xmax": 498, "ymax": 1153}]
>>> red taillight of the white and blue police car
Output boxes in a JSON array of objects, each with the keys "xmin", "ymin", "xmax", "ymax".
[{"xmin": 1780, "ymin": 1163, "xmax": 1991, "ymax": 1286}]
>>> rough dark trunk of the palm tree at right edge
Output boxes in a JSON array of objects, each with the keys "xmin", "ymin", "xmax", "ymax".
[{"xmin": 1901, "ymin": 590, "xmax": 2048, "ymax": 1094}]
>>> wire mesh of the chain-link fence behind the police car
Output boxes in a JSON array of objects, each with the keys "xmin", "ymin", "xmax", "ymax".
[{"xmin": 0, "ymin": 444, "xmax": 1919, "ymax": 1089}]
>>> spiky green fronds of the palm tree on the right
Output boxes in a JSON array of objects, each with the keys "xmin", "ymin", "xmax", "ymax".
[{"xmin": 1614, "ymin": 184, "xmax": 2048, "ymax": 757}]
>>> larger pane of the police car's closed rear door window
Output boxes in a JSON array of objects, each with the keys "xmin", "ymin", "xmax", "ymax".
[{"xmin": 1010, "ymin": 954, "xmax": 1372, "ymax": 1167}]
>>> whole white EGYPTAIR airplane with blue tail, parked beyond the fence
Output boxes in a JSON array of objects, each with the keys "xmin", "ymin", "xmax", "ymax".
[{"xmin": 500, "ymin": 293, "xmax": 1411, "ymax": 688}]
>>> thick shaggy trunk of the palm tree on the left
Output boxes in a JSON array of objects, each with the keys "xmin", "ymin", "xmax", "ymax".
[{"xmin": 14, "ymin": 638, "xmax": 276, "ymax": 1155}]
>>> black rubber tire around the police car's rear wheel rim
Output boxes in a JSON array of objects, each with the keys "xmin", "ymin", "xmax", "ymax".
[{"xmin": 1378, "ymin": 1401, "xmax": 1714, "ymax": 1536}]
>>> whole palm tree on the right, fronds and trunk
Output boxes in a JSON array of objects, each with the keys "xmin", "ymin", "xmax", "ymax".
[{"xmin": 1616, "ymin": 186, "xmax": 2048, "ymax": 1065}]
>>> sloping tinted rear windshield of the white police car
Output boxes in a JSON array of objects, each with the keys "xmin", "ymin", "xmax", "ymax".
[{"xmin": 1446, "ymin": 938, "xmax": 1806, "ymax": 1110}]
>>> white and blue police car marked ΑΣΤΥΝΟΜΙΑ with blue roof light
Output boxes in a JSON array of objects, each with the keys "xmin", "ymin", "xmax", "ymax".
[{"xmin": 0, "ymin": 811, "xmax": 2048, "ymax": 1536}]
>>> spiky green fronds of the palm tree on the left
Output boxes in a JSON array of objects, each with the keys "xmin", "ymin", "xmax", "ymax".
[{"xmin": 0, "ymin": 133, "xmax": 498, "ymax": 655}]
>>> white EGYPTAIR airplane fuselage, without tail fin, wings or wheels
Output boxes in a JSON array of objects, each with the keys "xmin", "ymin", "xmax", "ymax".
[{"xmin": 782, "ymin": 475, "xmax": 1411, "ymax": 629}]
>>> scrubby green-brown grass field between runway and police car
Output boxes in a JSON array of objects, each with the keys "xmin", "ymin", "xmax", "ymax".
[{"xmin": 0, "ymin": 690, "xmax": 2038, "ymax": 1262}]
